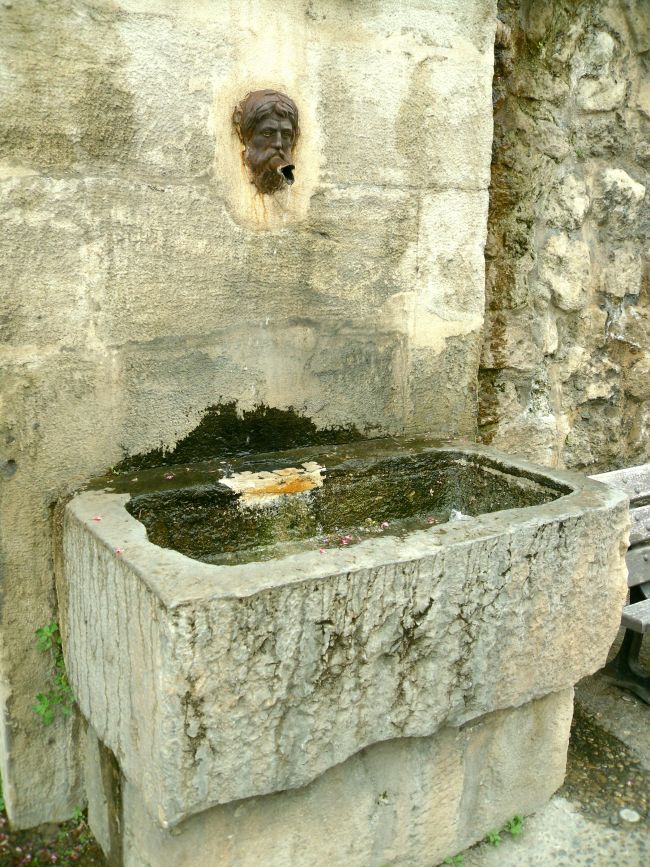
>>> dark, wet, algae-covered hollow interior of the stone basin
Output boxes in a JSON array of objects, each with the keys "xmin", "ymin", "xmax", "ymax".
[{"xmin": 109, "ymin": 441, "xmax": 567, "ymax": 564}]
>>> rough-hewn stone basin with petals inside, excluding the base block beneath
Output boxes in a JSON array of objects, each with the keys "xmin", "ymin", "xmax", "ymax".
[{"xmin": 61, "ymin": 440, "xmax": 627, "ymax": 828}]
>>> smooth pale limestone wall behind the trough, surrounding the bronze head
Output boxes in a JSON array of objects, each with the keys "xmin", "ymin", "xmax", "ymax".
[{"xmin": 0, "ymin": 0, "xmax": 496, "ymax": 825}]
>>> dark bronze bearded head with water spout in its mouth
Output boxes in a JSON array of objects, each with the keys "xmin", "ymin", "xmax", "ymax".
[{"xmin": 233, "ymin": 90, "xmax": 298, "ymax": 193}]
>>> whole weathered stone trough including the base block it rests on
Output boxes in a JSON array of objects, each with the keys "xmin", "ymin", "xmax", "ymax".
[{"xmin": 60, "ymin": 440, "xmax": 627, "ymax": 867}]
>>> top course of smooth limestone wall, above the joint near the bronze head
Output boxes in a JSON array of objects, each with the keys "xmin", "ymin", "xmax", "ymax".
[{"xmin": 0, "ymin": 0, "xmax": 496, "ymax": 189}]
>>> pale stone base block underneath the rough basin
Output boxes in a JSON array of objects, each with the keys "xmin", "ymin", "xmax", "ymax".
[{"xmin": 82, "ymin": 689, "xmax": 573, "ymax": 867}]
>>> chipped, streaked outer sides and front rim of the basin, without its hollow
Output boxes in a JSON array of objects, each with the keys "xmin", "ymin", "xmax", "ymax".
[{"xmin": 61, "ymin": 448, "xmax": 627, "ymax": 826}]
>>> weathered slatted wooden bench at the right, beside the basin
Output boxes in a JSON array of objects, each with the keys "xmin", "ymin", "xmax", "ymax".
[{"xmin": 591, "ymin": 464, "xmax": 650, "ymax": 704}]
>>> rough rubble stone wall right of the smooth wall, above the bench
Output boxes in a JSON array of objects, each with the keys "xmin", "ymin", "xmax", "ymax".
[{"xmin": 479, "ymin": 0, "xmax": 650, "ymax": 470}]
